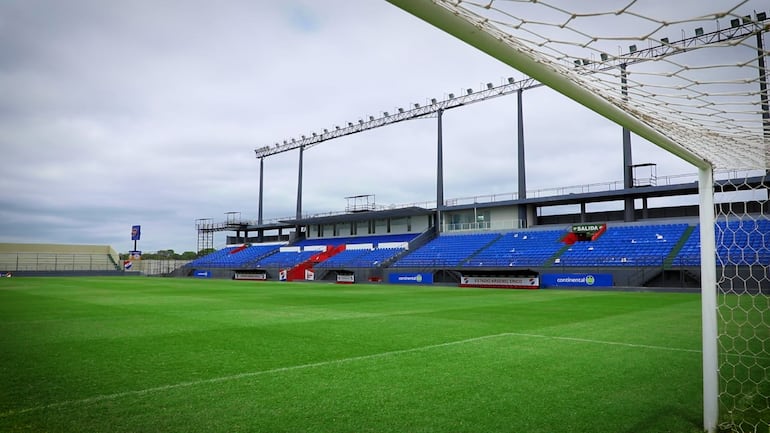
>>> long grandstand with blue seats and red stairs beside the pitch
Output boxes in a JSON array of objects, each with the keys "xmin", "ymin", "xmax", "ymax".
[{"xmin": 188, "ymin": 170, "xmax": 770, "ymax": 289}]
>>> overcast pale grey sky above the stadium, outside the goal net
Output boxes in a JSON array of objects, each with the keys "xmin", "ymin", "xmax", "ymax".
[{"xmin": 0, "ymin": 0, "xmax": 728, "ymax": 252}]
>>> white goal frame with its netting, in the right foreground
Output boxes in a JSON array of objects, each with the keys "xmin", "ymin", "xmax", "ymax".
[{"xmin": 388, "ymin": 0, "xmax": 770, "ymax": 432}]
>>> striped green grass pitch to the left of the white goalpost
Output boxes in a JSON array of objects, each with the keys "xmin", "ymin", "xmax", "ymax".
[{"xmin": 0, "ymin": 277, "xmax": 702, "ymax": 433}]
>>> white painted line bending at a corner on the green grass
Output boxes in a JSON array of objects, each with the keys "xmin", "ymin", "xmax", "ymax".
[{"xmin": 0, "ymin": 332, "xmax": 700, "ymax": 418}]
